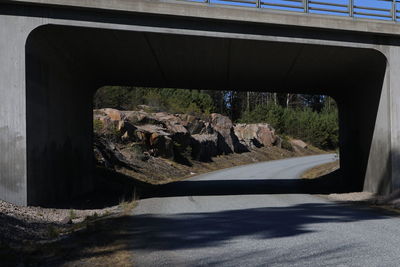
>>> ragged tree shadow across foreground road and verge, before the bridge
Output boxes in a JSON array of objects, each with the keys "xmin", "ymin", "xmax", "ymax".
[{"xmin": 3, "ymin": 203, "xmax": 388, "ymax": 266}]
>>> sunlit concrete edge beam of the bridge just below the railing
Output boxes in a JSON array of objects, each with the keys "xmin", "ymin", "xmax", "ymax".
[{"xmin": 3, "ymin": 0, "xmax": 399, "ymax": 35}]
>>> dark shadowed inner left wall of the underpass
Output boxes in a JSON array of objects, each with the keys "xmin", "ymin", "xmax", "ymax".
[{"xmin": 26, "ymin": 27, "xmax": 93, "ymax": 205}]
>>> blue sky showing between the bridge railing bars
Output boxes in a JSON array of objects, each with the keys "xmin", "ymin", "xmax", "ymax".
[{"xmin": 184, "ymin": 0, "xmax": 400, "ymax": 20}]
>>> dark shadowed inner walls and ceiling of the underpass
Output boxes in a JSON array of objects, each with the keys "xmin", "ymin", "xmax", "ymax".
[{"xmin": 26, "ymin": 25, "xmax": 390, "ymax": 205}]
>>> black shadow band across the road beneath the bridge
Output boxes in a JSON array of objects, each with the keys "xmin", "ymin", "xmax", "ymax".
[{"xmin": 62, "ymin": 168, "xmax": 349, "ymax": 209}]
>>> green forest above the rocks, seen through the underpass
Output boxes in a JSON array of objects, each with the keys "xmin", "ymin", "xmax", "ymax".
[{"xmin": 94, "ymin": 86, "xmax": 339, "ymax": 150}]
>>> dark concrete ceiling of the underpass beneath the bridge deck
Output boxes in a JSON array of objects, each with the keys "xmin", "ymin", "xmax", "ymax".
[{"xmin": 27, "ymin": 25, "xmax": 386, "ymax": 95}]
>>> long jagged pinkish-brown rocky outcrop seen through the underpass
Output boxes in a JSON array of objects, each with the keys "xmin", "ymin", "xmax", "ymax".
[{"xmin": 94, "ymin": 109, "xmax": 303, "ymax": 168}]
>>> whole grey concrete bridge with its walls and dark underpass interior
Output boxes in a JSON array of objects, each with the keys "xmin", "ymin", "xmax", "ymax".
[{"xmin": 0, "ymin": 0, "xmax": 400, "ymax": 205}]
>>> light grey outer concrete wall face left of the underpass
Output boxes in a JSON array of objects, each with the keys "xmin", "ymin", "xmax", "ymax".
[{"xmin": 0, "ymin": 15, "xmax": 40, "ymax": 205}]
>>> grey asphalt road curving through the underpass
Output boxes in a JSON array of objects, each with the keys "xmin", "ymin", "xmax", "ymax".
[{"xmin": 130, "ymin": 155, "xmax": 400, "ymax": 266}]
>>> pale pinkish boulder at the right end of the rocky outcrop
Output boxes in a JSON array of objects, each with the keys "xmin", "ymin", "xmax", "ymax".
[{"xmin": 234, "ymin": 123, "xmax": 277, "ymax": 149}]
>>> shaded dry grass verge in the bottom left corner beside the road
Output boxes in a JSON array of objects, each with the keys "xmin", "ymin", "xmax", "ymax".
[{"xmin": 0, "ymin": 215, "xmax": 134, "ymax": 267}]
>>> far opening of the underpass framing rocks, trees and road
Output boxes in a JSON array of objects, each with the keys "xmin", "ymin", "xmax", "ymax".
[{"xmin": 93, "ymin": 86, "xmax": 344, "ymax": 204}]
